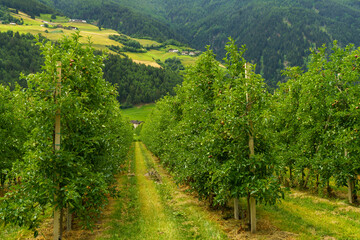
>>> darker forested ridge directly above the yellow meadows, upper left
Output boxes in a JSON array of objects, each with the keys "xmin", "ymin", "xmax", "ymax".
[{"xmin": 40, "ymin": 0, "xmax": 185, "ymax": 42}]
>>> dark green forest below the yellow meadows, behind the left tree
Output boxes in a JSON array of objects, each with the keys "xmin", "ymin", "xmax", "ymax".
[{"xmin": 0, "ymin": 31, "xmax": 184, "ymax": 107}]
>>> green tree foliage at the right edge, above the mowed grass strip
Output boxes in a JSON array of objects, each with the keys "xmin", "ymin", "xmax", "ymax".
[{"xmin": 274, "ymin": 42, "xmax": 360, "ymax": 191}]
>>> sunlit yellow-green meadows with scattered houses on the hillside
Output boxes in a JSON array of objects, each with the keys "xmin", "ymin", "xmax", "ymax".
[{"xmin": 0, "ymin": 12, "xmax": 196, "ymax": 67}]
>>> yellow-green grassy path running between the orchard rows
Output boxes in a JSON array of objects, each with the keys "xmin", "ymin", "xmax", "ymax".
[{"xmin": 97, "ymin": 142, "xmax": 227, "ymax": 240}]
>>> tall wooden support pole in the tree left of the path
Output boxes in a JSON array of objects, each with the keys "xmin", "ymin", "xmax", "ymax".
[{"xmin": 54, "ymin": 62, "xmax": 62, "ymax": 240}]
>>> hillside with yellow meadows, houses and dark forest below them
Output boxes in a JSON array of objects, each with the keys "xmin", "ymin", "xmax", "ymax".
[{"xmin": 0, "ymin": 8, "xmax": 191, "ymax": 107}]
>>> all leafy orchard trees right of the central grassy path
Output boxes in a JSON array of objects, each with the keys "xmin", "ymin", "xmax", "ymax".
[{"xmin": 142, "ymin": 40, "xmax": 360, "ymax": 231}]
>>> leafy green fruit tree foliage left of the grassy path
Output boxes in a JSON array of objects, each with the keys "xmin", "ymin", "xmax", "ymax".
[{"xmin": 0, "ymin": 34, "xmax": 132, "ymax": 232}]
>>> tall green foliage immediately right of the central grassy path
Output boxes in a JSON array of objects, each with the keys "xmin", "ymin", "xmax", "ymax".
[{"xmin": 142, "ymin": 40, "xmax": 282, "ymax": 204}]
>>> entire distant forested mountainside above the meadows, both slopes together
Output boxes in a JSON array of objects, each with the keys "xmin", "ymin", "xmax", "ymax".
[{"xmin": 38, "ymin": 0, "xmax": 360, "ymax": 88}]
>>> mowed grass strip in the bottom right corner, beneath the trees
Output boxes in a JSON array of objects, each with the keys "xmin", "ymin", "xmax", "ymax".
[{"xmin": 261, "ymin": 191, "xmax": 360, "ymax": 240}]
